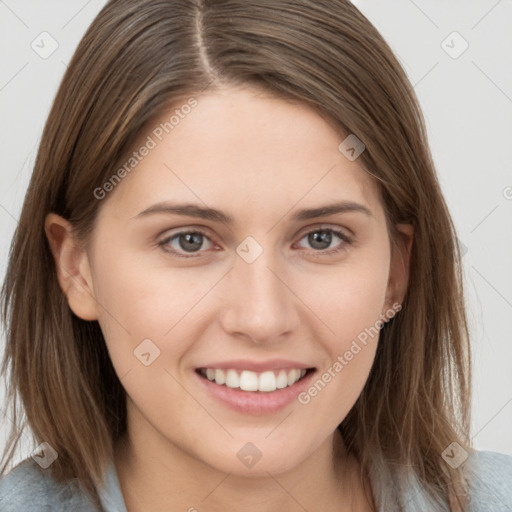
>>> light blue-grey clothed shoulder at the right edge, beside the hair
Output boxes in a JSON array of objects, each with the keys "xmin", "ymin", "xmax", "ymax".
[{"xmin": 463, "ymin": 451, "xmax": 512, "ymax": 512}]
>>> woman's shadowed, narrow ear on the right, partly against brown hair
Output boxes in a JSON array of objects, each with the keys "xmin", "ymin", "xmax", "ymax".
[{"xmin": 382, "ymin": 224, "xmax": 414, "ymax": 314}]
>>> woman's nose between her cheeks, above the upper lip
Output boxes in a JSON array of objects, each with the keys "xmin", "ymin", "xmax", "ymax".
[{"xmin": 221, "ymin": 250, "xmax": 300, "ymax": 344}]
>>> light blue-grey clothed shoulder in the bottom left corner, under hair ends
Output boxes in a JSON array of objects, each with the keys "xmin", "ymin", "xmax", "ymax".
[{"xmin": 0, "ymin": 457, "xmax": 98, "ymax": 512}]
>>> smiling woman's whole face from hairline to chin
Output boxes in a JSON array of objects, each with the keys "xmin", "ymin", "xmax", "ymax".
[{"xmin": 55, "ymin": 89, "xmax": 412, "ymax": 476}]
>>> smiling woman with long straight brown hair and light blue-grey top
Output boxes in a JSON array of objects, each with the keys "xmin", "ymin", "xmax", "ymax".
[{"xmin": 0, "ymin": 0, "xmax": 512, "ymax": 512}]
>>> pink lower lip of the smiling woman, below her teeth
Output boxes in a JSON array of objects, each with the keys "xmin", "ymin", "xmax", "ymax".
[{"xmin": 194, "ymin": 371, "xmax": 316, "ymax": 415}]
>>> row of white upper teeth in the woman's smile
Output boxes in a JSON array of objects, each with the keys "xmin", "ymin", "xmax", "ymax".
[{"xmin": 201, "ymin": 368, "xmax": 306, "ymax": 393}]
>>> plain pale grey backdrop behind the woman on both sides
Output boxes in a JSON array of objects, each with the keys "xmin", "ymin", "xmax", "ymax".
[{"xmin": 0, "ymin": 0, "xmax": 512, "ymax": 464}]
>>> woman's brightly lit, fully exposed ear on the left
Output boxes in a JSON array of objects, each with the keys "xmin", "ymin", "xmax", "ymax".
[{"xmin": 44, "ymin": 213, "xmax": 98, "ymax": 320}]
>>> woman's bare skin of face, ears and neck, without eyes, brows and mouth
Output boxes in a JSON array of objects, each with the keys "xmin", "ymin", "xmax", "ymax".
[{"xmin": 46, "ymin": 88, "xmax": 412, "ymax": 512}]
